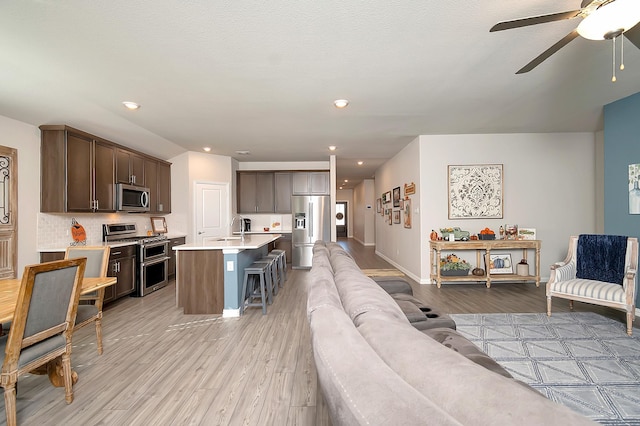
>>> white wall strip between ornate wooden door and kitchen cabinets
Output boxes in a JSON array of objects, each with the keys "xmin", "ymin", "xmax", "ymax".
[{"xmin": 0, "ymin": 116, "xmax": 40, "ymax": 276}]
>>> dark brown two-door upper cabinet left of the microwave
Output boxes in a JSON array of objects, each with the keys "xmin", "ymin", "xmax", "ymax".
[{"xmin": 40, "ymin": 126, "xmax": 116, "ymax": 213}]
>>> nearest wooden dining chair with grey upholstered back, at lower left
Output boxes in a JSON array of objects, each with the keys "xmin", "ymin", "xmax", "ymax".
[{"xmin": 0, "ymin": 258, "xmax": 87, "ymax": 426}]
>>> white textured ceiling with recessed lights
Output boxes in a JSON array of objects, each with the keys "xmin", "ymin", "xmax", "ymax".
[{"xmin": 0, "ymin": 0, "xmax": 640, "ymax": 188}]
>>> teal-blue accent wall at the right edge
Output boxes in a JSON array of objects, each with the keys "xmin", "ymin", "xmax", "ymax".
[{"xmin": 604, "ymin": 93, "xmax": 640, "ymax": 306}]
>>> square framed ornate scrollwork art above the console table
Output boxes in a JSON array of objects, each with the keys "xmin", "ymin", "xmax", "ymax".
[{"xmin": 448, "ymin": 164, "xmax": 503, "ymax": 219}]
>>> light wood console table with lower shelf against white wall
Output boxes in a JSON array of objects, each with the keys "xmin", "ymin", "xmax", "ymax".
[{"xmin": 430, "ymin": 240, "xmax": 541, "ymax": 288}]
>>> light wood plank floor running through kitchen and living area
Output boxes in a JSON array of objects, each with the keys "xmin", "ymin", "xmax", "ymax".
[{"xmin": 6, "ymin": 239, "xmax": 636, "ymax": 425}]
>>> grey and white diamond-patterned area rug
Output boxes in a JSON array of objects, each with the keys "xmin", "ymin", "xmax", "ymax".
[{"xmin": 450, "ymin": 312, "xmax": 640, "ymax": 425}]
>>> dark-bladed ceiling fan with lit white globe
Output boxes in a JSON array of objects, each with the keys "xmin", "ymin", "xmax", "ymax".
[{"xmin": 489, "ymin": 0, "xmax": 640, "ymax": 74}]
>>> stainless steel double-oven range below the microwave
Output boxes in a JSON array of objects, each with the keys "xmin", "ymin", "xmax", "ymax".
[{"xmin": 102, "ymin": 223, "xmax": 169, "ymax": 297}]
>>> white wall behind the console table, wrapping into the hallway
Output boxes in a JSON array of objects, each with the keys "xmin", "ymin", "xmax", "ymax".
[{"xmin": 376, "ymin": 133, "xmax": 597, "ymax": 283}]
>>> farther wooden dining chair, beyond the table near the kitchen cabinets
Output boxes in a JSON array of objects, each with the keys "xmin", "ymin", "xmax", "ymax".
[{"xmin": 64, "ymin": 246, "xmax": 110, "ymax": 355}]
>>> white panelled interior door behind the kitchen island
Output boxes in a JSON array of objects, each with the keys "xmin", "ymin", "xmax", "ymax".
[{"xmin": 194, "ymin": 182, "xmax": 229, "ymax": 243}]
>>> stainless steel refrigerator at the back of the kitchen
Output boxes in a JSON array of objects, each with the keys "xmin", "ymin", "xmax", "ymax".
[{"xmin": 291, "ymin": 195, "xmax": 331, "ymax": 269}]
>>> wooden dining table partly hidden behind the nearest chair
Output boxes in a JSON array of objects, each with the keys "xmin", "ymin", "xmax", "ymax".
[{"xmin": 0, "ymin": 277, "xmax": 118, "ymax": 387}]
